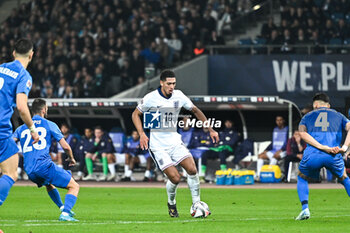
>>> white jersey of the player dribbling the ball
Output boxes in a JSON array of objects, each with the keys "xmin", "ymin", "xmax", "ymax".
[{"xmin": 137, "ymin": 88, "xmax": 193, "ymax": 151}]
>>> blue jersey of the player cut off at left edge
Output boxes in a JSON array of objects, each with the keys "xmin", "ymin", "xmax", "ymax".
[{"xmin": 0, "ymin": 60, "xmax": 32, "ymax": 140}]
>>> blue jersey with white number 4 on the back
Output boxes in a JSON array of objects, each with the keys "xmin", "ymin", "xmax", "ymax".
[{"xmin": 299, "ymin": 108, "xmax": 349, "ymax": 156}]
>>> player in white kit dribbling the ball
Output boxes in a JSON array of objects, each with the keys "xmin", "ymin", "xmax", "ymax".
[{"xmin": 132, "ymin": 70, "xmax": 219, "ymax": 217}]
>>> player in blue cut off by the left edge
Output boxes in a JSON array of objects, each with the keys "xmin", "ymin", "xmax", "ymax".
[{"xmin": 0, "ymin": 39, "xmax": 39, "ymax": 205}]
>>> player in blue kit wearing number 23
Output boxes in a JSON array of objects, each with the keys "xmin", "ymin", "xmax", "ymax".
[{"xmin": 13, "ymin": 99, "xmax": 79, "ymax": 221}]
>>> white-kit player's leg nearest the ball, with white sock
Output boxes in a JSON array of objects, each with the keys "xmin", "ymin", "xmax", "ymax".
[{"xmin": 180, "ymin": 156, "xmax": 200, "ymax": 203}]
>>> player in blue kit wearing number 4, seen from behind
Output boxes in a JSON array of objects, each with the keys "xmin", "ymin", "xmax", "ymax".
[{"xmin": 295, "ymin": 93, "xmax": 350, "ymax": 220}]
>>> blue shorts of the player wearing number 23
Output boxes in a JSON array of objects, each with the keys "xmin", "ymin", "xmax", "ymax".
[{"xmin": 28, "ymin": 161, "xmax": 72, "ymax": 188}]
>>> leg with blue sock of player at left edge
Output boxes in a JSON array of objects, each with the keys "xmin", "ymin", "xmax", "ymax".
[{"xmin": 0, "ymin": 155, "xmax": 18, "ymax": 205}]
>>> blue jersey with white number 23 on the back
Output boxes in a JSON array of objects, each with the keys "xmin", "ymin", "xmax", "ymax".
[{"xmin": 13, "ymin": 115, "xmax": 63, "ymax": 174}]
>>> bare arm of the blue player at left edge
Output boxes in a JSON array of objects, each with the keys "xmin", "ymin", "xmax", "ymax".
[{"xmin": 16, "ymin": 93, "xmax": 39, "ymax": 144}]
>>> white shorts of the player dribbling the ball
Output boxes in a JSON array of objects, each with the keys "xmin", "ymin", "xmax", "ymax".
[{"xmin": 149, "ymin": 143, "xmax": 192, "ymax": 171}]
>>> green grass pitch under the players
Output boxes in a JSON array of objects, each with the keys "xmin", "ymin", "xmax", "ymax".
[{"xmin": 0, "ymin": 186, "xmax": 350, "ymax": 233}]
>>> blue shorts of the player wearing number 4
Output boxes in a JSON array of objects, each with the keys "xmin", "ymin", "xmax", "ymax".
[{"xmin": 299, "ymin": 154, "xmax": 344, "ymax": 180}]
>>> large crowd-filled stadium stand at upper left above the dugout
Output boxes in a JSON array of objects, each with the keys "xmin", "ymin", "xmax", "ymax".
[{"xmin": 0, "ymin": 0, "xmax": 270, "ymax": 98}]
